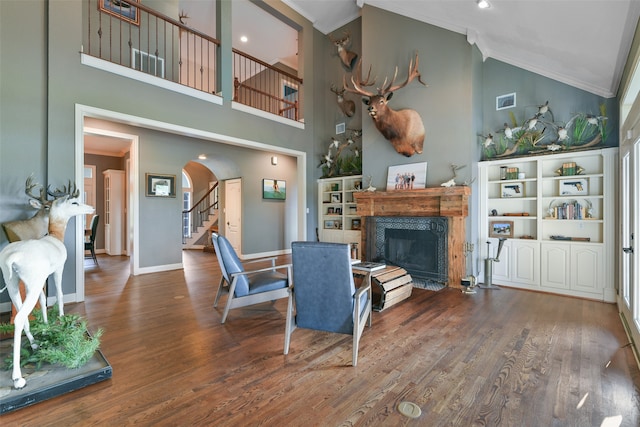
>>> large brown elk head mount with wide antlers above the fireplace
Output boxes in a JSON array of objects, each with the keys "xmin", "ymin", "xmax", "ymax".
[{"xmin": 343, "ymin": 53, "xmax": 427, "ymax": 157}]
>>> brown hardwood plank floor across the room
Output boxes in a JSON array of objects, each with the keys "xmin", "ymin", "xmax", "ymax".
[{"xmin": 0, "ymin": 251, "xmax": 640, "ymax": 426}]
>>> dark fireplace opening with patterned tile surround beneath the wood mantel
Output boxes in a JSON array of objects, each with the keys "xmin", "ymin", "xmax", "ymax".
[{"xmin": 366, "ymin": 217, "xmax": 448, "ymax": 287}]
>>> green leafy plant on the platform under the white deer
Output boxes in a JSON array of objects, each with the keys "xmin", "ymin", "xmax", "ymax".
[{"xmin": 0, "ymin": 307, "xmax": 103, "ymax": 369}]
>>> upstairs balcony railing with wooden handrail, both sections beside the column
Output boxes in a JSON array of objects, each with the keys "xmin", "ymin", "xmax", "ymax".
[{"xmin": 83, "ymin": 0, "xmax": 302, "ymax": 121}]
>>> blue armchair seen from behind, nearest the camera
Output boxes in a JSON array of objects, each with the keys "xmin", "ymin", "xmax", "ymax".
[{"xmin": 284, "ymin": 242, "xmax": 371, "ymax": 366}]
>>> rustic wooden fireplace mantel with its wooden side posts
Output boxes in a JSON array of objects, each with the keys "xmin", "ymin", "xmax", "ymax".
[{"xmin": 354, "ymin": 186, "xmax": 471, "ymax": 288}]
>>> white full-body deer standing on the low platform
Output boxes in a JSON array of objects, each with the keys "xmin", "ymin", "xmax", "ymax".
[{"xmin": 0, "ymin": 179, "xmax": 94, "ymax": 389}]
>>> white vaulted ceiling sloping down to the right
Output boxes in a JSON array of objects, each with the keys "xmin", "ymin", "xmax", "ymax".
[{"xmin": 282, "ymin": 0, "xmax": 640, "ymax": 98}]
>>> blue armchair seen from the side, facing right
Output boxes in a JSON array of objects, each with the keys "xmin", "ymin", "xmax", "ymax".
[{"xmin": 211, "ymin": 233, "xmax": 291, "ymax": 323}]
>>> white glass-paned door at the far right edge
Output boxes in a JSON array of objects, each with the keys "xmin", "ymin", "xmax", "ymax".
[{"xmin": 618, "ymin": 139, "xmax": 640, "ymax": 345}]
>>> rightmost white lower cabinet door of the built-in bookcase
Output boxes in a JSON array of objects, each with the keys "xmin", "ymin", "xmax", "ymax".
[{"xmin": 571, "ymin": 244, "xmax": 604, "ymax": 293}]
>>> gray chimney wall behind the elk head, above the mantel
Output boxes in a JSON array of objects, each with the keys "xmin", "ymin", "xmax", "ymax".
[{"xmin": 362, "ymin": 6, "xmax": 477, "ymax": 188}]
